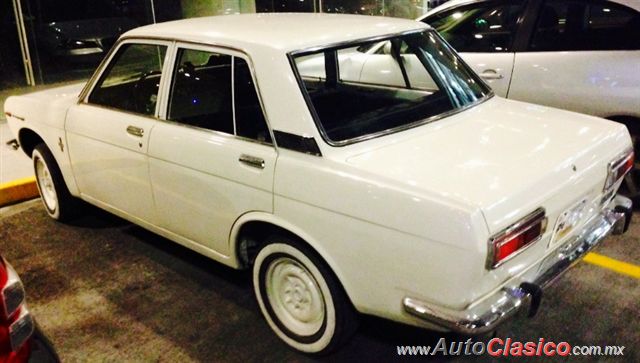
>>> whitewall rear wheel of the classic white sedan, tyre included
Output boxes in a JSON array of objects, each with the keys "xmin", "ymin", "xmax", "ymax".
[{"xmin": 253, "ymin": 236, "xmax": 357, "ymax": 354}]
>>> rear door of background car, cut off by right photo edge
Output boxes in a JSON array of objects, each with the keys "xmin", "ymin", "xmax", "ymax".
[{"xmin": 509, "ymin": 0, "xmax": 640, "ymax": 117}]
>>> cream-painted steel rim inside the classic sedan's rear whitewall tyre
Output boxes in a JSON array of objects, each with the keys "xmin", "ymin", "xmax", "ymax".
[{"xmin": 265, "ymin": 257, "xmax": 325, "ymax": 336}]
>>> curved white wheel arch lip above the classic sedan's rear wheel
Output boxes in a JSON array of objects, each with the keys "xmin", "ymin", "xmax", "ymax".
[{"xmin": 229, "ymin": 212, "xmax": 355, "ymax": 306}]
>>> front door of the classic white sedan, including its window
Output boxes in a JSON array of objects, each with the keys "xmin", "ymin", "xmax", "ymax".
[{"xmin": 65, "ymin": 40, "xmax": 168, "ymax": 223}]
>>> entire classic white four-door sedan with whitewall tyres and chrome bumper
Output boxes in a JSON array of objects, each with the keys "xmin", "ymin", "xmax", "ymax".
[{"xmin": 5, "ymin": 14, "xmax": 633, "ymax": 353}]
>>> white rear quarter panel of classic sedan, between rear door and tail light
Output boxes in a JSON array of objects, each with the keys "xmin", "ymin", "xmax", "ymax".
[{"xmin": 274, "ymin": 150, "xmax": 488, "ymax": 324}]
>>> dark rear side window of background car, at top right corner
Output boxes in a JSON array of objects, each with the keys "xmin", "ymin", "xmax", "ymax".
[{"xmin": 529, "ymin": 0, "xmax": 640, "ymax": 51}]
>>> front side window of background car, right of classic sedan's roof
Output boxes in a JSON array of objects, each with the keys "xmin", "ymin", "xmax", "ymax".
[{"xmin": 424, "ymin": 0, "xmax": 525, "ymax": 52}]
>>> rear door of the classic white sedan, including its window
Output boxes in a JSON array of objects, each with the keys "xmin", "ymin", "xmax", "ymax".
[{"xmin": 149, "ymin": 45, "xmax": 277, "ymax": 257}]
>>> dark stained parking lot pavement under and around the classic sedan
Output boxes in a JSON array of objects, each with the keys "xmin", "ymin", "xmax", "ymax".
[{"xmin": 0, "ymin": 200, "xmax": 640, "ymax": 362}]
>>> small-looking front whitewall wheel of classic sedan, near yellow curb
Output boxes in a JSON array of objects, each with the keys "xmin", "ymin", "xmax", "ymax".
[{"xmin": 31, "ymin": 144, "xmax": 75, "ymax": 221}]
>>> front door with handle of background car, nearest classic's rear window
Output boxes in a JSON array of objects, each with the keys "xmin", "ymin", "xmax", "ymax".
[{"xmin": 423, "ymin": 0, "xmax": 527, "ymax": 97}]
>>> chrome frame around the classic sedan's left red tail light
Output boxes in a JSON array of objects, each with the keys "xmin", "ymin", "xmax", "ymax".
[{"xmin": 486, "ymin": 207, "xmax": 548, "ymax": 270}]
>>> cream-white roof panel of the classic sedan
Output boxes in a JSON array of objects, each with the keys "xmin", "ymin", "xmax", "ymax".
[{"xmin": 124, "ymin": 13, "xmax": 429, "ymax": 52}]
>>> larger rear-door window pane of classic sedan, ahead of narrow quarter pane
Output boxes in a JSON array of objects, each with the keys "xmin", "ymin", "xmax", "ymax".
[{"xmin": 167, "ymin": 49, "xmax": 233, "ymax": 134}]
